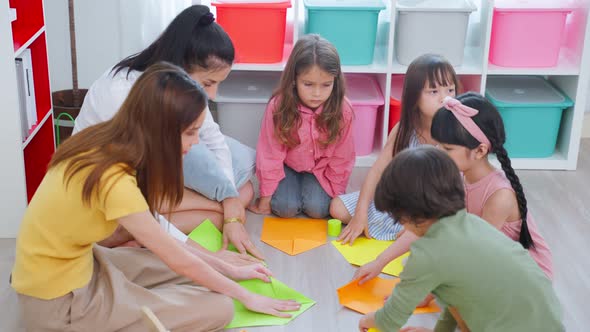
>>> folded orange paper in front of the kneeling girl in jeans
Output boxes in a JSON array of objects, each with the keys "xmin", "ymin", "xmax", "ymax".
[{"xmin": 260, "ymin": 217, "xmax": 328, "ymax": 256}]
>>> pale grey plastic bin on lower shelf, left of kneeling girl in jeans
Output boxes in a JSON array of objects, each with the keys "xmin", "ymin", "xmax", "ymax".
[{"xmin": 215, "ymin": 71, "xmax": 280, "ymax": 149}]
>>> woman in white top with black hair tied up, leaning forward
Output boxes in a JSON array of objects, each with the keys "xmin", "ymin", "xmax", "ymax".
[{"xmin": 74, "ymin": 5, "xmax": 264, "ymax": 262}]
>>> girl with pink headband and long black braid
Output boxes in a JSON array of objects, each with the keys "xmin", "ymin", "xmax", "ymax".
[{"xmin": 431, "ymin": 92, "xmax": 553, "ymax": 279}]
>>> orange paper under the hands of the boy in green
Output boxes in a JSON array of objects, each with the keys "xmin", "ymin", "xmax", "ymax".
[{"xmin": 337, "ymin": 277, "xmax": 440, "ymax": 315}]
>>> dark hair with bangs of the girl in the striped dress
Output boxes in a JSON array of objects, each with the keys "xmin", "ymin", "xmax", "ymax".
[{"xmin": 393, "ymin": 54, "xmax": 461, "ymax": 156}]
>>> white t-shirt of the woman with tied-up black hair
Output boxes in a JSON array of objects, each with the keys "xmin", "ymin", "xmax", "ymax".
[{"xmin": 74, "ymin": 65, "xmax": 235, "ymax": 185}]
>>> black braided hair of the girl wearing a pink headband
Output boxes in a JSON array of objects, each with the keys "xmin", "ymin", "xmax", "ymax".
[{"xmin": 431, "ymin": 92, "xmax": 535, "ymax": 249}]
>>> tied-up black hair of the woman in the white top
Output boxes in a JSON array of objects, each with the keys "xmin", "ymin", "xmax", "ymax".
[{"xmin": 113, "ymin": 5, "xmax": 235, "ymax": 74}]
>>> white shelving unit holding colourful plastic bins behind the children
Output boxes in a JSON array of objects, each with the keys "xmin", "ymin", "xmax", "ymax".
[{"xmin": 209, "ymin": 0, "xmax": 590, "ymax": 170}]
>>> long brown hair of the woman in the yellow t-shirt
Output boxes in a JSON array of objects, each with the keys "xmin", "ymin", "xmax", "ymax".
[{"xmin": 49, "ymin": 63, "xmax": 207, "ymax": 213}]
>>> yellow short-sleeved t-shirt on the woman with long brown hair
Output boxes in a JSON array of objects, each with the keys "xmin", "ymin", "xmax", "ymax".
[{"xmin": 12, "ymin": 162, "xmax": 149, "ymax": 300}]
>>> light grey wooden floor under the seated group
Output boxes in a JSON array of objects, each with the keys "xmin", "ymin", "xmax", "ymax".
[{"xmin": 0, "ymin": 140, "xmax": 590, "ymax": 332}]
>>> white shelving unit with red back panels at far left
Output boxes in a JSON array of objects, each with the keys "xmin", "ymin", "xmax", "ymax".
[{"xmin": 0, "ymin": 0, "xmax": 55, "ymax": 238}]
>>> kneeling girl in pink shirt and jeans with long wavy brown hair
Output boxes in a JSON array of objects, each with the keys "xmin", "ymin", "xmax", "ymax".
[{"xmin": 249, "ymin": 35, "xmax": 355, "ymax": 218}]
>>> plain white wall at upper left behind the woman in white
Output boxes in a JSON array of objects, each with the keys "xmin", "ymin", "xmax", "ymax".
[{"xmin": 45, "ymin": 0, "xmax": 191, "ymax": 91}]
